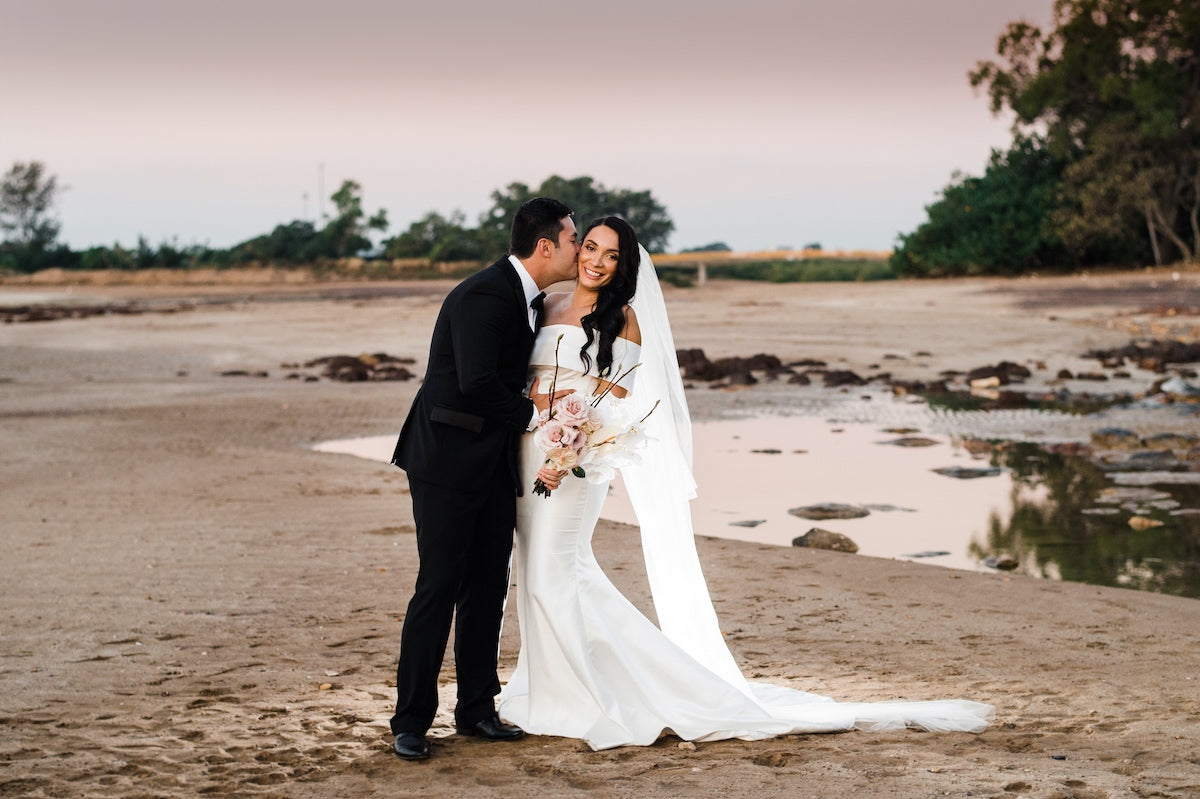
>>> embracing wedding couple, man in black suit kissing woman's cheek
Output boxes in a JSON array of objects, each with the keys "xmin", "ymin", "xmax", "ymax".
[{"xmin": 391, "ymin": 198, "xmax": 992, "ymax": 759}]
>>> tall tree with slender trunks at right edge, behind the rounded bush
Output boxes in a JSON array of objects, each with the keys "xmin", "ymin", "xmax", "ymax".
[{"xmin": 970, "ymin": 0, "xmax": 1200, "ymax": 264}]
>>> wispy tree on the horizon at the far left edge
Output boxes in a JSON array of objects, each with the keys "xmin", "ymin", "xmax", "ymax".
[{"xmin": 0, "ymin": 161, "xmax": 60, "ymax": 271}]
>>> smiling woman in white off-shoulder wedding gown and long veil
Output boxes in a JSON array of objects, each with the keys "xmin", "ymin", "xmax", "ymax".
[{"xmin": 498, "ymin": 216, "xmax": 991, "ymax": 750}]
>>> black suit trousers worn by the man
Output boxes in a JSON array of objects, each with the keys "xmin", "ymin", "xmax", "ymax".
[{"xmin": 391, "ymin": 462, "xmax": 516, "ymax": 733}]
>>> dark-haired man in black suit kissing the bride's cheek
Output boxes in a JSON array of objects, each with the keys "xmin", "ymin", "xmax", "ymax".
[{"xmin": 391, "ymin": 197, "xmax": 578, "ymax": 759}]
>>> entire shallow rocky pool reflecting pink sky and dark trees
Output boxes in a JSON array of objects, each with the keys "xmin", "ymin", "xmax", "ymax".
[{"xmin": 317, "ymin": 416, "xmax": 1200, "ymax": 597}]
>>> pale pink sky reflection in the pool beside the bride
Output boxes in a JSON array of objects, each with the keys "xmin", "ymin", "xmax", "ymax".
[{"xmin": 604, "ymin": 416, "xmax": 1013, "ymax": 569}]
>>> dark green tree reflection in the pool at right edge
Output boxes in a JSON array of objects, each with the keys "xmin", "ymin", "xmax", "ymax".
[{"xmin": 970, "ymin": 443, "xmax": 1200, "ymax": 597}]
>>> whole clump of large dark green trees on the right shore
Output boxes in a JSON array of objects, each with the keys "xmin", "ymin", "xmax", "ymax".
[{"xmin": 892, "ymin": 0, "xmax": 1200, "ymax": 276}]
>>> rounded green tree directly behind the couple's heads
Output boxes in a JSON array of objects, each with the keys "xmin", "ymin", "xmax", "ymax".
[{"xmin": 479, "ymin": 175, "xmax": 674, "ymax": 252}]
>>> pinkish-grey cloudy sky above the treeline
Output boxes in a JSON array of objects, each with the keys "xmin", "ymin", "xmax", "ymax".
[{"xmin": 0, "ymin": 0, "xmax": 1052, "ymax": 250}]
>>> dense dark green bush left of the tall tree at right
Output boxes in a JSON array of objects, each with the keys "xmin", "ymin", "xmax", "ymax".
[{"xmin": 890, "ymin": 137, "xmax": 1069, "ymax": 277}]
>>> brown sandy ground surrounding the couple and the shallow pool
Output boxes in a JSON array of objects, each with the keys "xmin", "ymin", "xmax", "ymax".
[{"xmin": 0, "ymin": 270, "xmax": 1200, "ymax": 799}]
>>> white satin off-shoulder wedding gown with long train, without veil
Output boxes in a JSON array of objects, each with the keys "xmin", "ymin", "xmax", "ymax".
[{"xmin": 498, "ymin": 325, "xmax": 991, "ymax": 750}]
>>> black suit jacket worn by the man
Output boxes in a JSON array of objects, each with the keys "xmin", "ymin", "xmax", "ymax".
[{"xmin": 391, "ymin": 257, "xmax": 534, "ymax": 495}]
